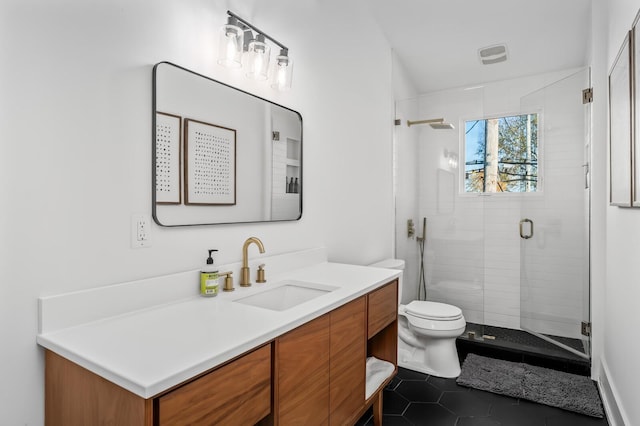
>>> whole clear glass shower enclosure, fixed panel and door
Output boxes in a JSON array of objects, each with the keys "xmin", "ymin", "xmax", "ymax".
[{"xmin": 394, "ymin": 69, "xmax": 590, "ymax": 358}]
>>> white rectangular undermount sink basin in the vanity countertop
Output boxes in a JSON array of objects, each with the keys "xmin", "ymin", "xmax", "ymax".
[{"xmin": 234, "ymin": 280, "xmax": 338, "ymax": 311}]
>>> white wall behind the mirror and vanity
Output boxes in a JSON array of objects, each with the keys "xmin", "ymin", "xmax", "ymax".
[{"xmin": 0, "ymin": 0, "xmax": 393, "ymax": 425}]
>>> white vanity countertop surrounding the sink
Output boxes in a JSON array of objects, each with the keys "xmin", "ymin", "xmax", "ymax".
[{"xmin": 37, "ymin": 255, "xmax": 400, "ymax": 398}]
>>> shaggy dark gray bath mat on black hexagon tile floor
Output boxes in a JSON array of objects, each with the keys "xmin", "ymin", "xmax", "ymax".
[{"xmin": 456, "ymin": 354, "xmax": 604, "ymax": 418}]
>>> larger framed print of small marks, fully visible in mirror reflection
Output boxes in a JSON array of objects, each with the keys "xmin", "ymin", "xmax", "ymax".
[{"xmin": 184, "ymin": 118, "xmax": 236, "ymax": 205}]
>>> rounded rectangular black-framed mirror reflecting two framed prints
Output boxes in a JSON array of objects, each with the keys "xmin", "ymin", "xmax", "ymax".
[{"xmin": 152, "ymin": 62, "xmax": 302, "ymax": 226}]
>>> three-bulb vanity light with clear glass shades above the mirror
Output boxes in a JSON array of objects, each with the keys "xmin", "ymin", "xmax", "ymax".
[{"xmin": 218, "ymin": 11, "xmax": 293, "ymax": 91}]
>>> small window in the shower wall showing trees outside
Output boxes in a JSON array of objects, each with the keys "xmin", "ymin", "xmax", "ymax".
[{"xmin": 464, "ymin": 114, "xmax": 539, "ymax": 193}]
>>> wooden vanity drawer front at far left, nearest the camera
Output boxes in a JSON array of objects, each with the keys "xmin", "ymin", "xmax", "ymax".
[{"xmin": 158, "ymin": 345, "xmax": 271, "ymax": 426}]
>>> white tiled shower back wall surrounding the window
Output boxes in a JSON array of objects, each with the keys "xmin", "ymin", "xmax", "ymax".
[{"xmin": 418, "ymin": 70, "xmax": 586, "ymax": 337}]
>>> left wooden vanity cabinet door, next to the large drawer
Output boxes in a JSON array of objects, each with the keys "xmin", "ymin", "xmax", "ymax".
[{"xmin": 276, "ymin": 314, "xmax": 330, "ymax": 426}]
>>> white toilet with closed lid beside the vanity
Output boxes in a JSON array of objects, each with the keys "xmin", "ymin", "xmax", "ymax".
[{"xmin": 370, "ymin": 259, "xmax": 466, "ymax": 378}]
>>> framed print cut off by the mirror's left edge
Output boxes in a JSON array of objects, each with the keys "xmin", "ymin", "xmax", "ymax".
[{"xmin": 156, "ymin": 112, "xmax": 182, "ymax": 204}]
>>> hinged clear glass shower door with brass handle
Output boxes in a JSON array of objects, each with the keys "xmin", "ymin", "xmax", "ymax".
[{"xmin": 520, "ymin": 69, "xmax": 591, "ymax": 358}]
